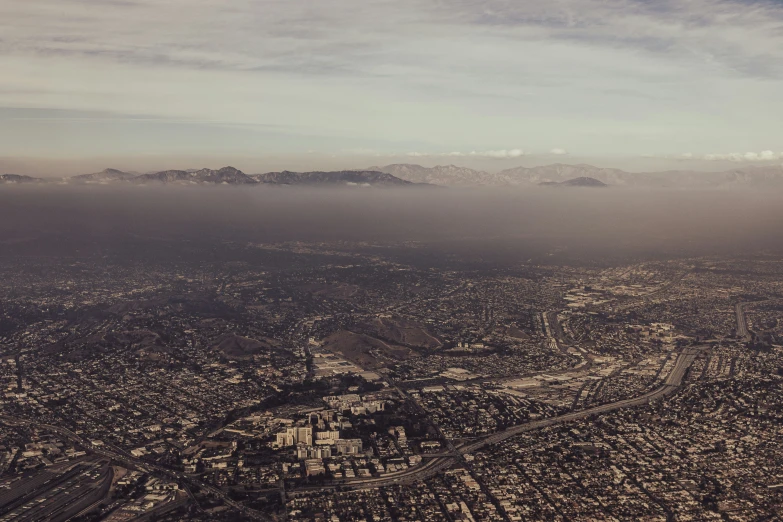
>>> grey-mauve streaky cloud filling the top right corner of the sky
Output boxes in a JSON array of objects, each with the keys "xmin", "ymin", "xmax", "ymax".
[{"xmin": 453, "ymin": 0, "xmax": 783, "ymax": 77}]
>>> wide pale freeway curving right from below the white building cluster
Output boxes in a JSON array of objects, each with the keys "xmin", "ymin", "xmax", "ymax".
[{"xmin": 320, "ymin": 347, "xmax": 703, "ymax": 491}]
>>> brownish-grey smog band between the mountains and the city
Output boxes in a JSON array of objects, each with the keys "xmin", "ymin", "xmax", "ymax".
[{"xmin": 6, "ymin": 185, "xmax": 783, "ymax": 262}]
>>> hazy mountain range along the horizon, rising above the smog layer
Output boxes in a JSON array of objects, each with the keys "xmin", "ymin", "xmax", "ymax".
[{"xmin": 0, "ymin": 163, "xmax": 783, "ymax": 189}]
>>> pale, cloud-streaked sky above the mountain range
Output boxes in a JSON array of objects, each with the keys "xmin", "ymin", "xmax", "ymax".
[{"xmin": 0, "ymin": 0, "xmax": 783, "ymax": 174}]
